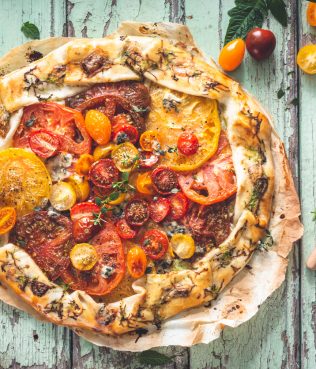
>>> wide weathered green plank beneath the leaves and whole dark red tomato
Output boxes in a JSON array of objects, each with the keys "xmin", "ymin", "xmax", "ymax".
[{"xmin": 186, "ymin": 0, "xmax": 299, "ymax": 369}]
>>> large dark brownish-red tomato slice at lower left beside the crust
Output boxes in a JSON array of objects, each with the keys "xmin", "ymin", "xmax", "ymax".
[{"xmin": 10, "ymin": 211, "xmax": 74, "ymax": 280}]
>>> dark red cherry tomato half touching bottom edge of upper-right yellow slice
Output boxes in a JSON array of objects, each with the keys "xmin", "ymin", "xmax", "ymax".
[{"xmin": 151, "ymin": 166, "xmax": 179, "ymax": 195}]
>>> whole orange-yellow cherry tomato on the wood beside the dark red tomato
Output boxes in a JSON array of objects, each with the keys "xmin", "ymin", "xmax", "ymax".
[{"xmin": 218, "ymin": 38, "xmax": 246, "ymax": 72}]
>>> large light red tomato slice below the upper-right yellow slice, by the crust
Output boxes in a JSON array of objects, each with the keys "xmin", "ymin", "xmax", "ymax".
[{"xmin": 179, "ymin": 153, "xmax": 237, "ymax": 205}]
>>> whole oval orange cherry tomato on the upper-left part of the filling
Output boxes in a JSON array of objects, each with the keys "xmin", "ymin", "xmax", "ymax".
[{"xmin": 85, "ymin": 110, "xmax": 111, "ymax": 145}]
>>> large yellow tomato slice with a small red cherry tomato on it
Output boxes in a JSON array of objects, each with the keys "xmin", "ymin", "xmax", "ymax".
[{"xmin": 147, "ymin": 85, "xmax": 221, "ymax": 171}]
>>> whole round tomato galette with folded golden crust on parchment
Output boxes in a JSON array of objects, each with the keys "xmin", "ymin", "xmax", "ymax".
[{"xmin": 0, "ymin": 24, "xmax": 302, "ymax": 335}]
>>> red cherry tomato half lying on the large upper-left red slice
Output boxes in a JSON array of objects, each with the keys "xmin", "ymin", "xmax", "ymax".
[{"xmin": 29, "ymin": 129, "xmax": 60, "ymax": 159}]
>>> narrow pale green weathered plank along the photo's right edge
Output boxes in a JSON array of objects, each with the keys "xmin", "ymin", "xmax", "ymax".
[{"xmin": 299, "ymin": 1, "xmax": 316, "ymax": 369}]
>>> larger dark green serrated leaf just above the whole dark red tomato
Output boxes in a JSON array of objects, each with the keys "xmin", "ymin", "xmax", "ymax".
[{"xmin": 224, "ymin": 0, "xmax": 268, "ymax": 44}]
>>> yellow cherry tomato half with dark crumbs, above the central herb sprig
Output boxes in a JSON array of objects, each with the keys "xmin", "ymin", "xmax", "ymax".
[{"xmin": 111, "ymin": 142, "xmax": 139, "ymax": 172}]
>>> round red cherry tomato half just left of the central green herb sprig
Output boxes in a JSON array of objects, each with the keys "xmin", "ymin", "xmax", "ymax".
[{"xmin": 89, "ymin": 159, "xmax": 120, "ymax": 190}]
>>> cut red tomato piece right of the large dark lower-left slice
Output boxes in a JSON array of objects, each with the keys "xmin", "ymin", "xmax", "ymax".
[{"xmin": 70, "ymin": 202, "xmax": 100, "ymax": 242}]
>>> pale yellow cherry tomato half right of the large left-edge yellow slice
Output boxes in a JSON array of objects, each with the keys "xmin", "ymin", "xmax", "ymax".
[{"xmin": 49, "ymin": 181, "xmax": 77, "ymax": 211}]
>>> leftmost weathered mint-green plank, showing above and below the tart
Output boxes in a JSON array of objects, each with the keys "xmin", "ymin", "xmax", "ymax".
[{"xmin": 0, "ymin": 0, "xmax": 70, "ymax": 369}]
